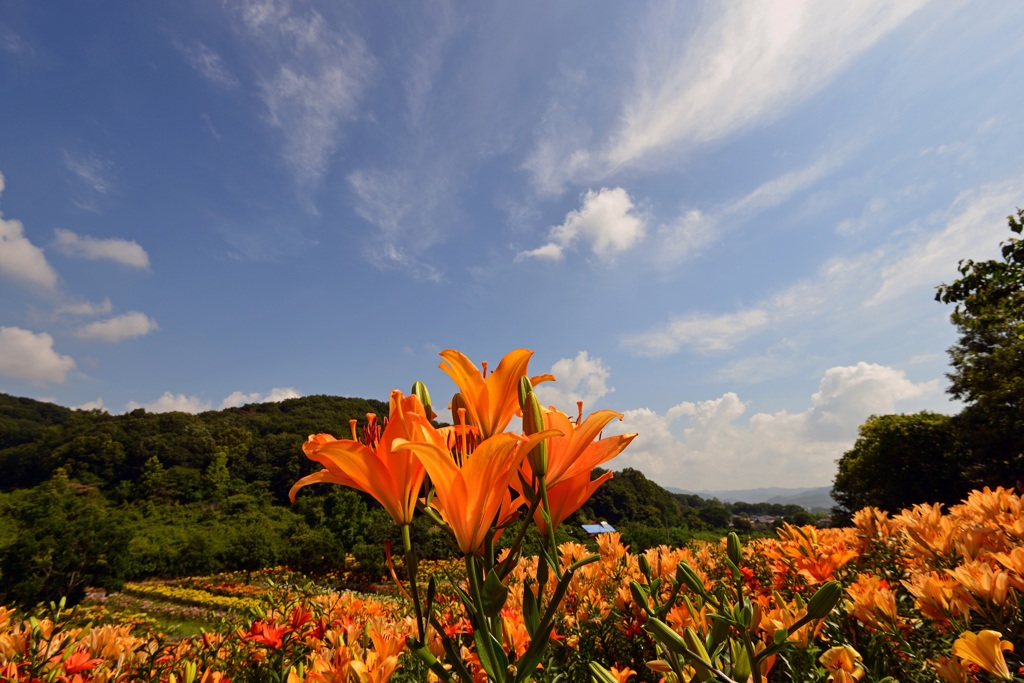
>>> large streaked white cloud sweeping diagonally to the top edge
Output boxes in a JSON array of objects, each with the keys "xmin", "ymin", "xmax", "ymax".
[{"xmin": 526, "ymin": 0, "xmax": 927, "ymax": 191}]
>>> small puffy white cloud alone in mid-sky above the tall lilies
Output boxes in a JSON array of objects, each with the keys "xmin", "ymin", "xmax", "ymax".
[{"xmin": 516, "ymin": 187, "xmax": 646, "ymax": 261}]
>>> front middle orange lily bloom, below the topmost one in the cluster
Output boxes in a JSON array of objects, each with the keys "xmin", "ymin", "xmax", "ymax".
[{"xmin": 394, "ymin": 431, "xmax": 551, "ymax": 555}]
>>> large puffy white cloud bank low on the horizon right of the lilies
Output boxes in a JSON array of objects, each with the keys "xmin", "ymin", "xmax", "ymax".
[{"xmin": 607, "ymin": 362, "xmax": 939, "ymax": 489}]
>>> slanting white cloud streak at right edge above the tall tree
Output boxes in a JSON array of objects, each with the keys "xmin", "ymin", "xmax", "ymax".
[{"xmin": 865, "ymin": 184, "xmax": 1021, "ymax": 306}]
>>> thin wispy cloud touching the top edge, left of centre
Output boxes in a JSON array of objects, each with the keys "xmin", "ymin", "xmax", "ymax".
[{"xmin": 236, "ymin": 0, "xmax": 377, "ymax": 182}]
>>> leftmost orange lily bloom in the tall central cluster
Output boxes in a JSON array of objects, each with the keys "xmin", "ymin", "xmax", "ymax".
[{"xmin": 288, "ymin": 390, "xmax": 445, "ymax": 526}]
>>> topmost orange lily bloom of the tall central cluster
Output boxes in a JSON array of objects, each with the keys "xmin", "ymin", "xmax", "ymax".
[{"xmin": 440, "ymin": 348, "xmax": 555, "ymax": 438}]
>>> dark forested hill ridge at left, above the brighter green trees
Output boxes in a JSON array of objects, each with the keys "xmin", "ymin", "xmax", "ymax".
[{"xmin": 0, "ymin": 394, "xmax": 388, "ymax": 504}]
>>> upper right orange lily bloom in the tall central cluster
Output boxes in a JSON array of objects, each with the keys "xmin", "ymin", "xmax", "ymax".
[{"xmin": 523, "ymin": 408, "xmax": 637, "ymax": 489}]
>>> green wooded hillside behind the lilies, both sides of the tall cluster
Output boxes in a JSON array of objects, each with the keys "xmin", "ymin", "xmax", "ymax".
[{"xmin": 0, "ymin": 394, "xmax": 811, "ymax": 604}]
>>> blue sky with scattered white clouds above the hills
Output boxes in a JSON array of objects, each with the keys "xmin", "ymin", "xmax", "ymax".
[{"xmin": 0, "ymin": 0, "xmax": 1024, "ymax": 489}]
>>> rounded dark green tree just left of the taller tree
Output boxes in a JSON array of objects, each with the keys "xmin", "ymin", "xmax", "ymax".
[{"xmin": 831, "ymin": 411, "xmax": 968, "ymax": 519}]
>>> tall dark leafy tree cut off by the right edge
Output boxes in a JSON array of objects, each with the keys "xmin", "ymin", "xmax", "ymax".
[{"xmin": 935, "ymin": 209, "xmax": 1024, "ymax": 486}]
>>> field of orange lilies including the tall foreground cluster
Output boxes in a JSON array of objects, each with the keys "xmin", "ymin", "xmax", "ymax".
[{"xmin": 0, "ymin": 349, "xmax": 1024, "ymax": 683}]
